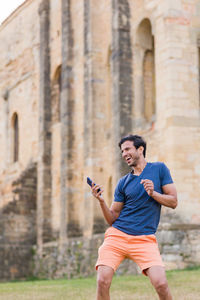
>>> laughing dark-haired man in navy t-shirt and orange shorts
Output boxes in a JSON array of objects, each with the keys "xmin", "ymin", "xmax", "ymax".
[{"xmin": 92, "ymin": 135, "xmax": 177, "ymax": 300}]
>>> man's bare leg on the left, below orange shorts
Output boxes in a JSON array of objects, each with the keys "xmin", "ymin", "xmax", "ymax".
[{"xmin": 97, "ymin": 265, "xmax": 114, "ymax": 300}]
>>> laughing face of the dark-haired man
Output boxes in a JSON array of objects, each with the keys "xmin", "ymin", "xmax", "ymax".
[{"xmin": 121, "ymin": 141, "xmax": 141, "ymax": 167}]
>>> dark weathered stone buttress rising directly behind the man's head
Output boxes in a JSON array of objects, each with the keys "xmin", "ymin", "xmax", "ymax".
[{"xmin": 111, "ymin": 0, "xmax": 134, "ymax": 175}]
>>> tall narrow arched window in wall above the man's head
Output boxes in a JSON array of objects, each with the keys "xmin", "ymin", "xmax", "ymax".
[{"xmin": 135, "ymin": 19, "xmax": 156, "ymax": 123}]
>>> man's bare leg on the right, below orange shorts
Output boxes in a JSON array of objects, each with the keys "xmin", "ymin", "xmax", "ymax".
[{"xmin": 146, "ymin": 266, "xmax": 172, "ymax": 300}]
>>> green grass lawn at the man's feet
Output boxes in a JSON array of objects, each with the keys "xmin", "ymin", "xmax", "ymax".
[{"xmin": 0, "ymin": 268, "xmax": 200, "ymax": 300}]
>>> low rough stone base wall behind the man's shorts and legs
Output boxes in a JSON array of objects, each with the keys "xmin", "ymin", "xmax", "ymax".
[{"xmin": 33, "ymin": 223, "xmax": 200, "ymax": 278}]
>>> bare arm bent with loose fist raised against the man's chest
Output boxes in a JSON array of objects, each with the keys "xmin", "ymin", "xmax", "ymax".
[{"xmin": 141, "ymin": 179, "xmax": 178, "ymax": 208}]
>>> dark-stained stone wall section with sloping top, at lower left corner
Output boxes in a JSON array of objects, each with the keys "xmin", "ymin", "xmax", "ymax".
[{"xmin": 0, "ymin": 164, "xmax": 37, "ymax": 280}]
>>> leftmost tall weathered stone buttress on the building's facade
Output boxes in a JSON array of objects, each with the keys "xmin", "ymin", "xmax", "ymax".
[{"xmin": 37, "ymin": 0, "xmax": 51, "ymax": 252}]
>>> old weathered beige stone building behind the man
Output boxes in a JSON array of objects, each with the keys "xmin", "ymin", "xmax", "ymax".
[{"xmin": 0, "ymin": 0, "xmax": 200, "ymax": 279}]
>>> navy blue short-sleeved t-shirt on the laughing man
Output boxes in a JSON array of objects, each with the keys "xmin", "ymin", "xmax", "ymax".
[{"xmin": 112, "ymin": 162, "xmax": 173, "ymax": 235}]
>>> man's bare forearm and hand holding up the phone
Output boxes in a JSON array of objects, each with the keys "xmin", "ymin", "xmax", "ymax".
[{"xmin": 92, "ymin": 184, "xmax": 123, "ymax": 225}]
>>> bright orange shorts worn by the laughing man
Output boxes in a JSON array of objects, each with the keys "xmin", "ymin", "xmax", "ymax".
[{"xmin": 96, "ymin": 227, "xmax": 164, "ymax": 275}]
